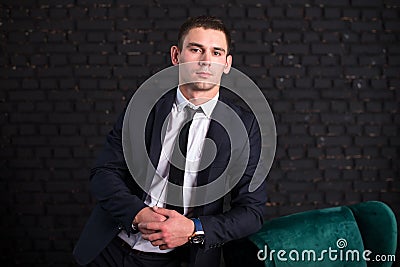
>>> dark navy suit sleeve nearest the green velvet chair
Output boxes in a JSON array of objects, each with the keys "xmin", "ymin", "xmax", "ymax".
[{"xmin": 200, "ymin": 117, "xmax": 267, "ymax": 250}]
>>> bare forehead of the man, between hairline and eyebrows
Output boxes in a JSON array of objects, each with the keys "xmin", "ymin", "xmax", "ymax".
[{"xmin": 183, "ymin": 27, "xmax": 228, "ymax": 49}]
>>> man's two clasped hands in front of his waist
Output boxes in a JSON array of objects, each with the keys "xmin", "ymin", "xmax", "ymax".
[{"xmin": 134, "ymin": 207, "xmax": 194, "ymax": 250}]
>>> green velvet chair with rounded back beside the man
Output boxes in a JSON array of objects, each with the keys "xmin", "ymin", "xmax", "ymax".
[{"xmin": 249, "ymin": 201, "xmax": 397, "ymax": 267}]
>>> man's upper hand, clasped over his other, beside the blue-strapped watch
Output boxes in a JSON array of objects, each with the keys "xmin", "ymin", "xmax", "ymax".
[{"xmin": 139, "ymin": 207, "xmax": 194, "ymax": 250}]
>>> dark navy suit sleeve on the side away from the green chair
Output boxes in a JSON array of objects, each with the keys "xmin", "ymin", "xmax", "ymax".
[{"xmin": 90, "ymin": 112, "xmax": 146, "ymax": 233}]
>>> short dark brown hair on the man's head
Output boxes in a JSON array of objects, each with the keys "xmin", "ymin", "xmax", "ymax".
[{"xmin": 178, "ymin": 16, "xmax": 232, "ymax": 54}]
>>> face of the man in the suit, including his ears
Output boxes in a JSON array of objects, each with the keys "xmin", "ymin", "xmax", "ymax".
[{"xmin": 171, "ymin": 28, "xmax": 232, "ymax": 90}]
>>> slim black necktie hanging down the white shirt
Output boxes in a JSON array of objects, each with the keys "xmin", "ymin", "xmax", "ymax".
[{"xmin": 166, "ymin": 106, "xmax": 200, "ymax": 214}]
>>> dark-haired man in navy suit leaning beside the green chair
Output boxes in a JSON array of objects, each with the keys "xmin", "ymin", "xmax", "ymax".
[{"xmin": 74, "ymin": 16, "xmax": 266, "ymax": 267}]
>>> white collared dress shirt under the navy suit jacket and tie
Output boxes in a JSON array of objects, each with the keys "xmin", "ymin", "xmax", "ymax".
[{"xmin": 119, "ymin": 88, "xmax": 219, "ymax": 253}]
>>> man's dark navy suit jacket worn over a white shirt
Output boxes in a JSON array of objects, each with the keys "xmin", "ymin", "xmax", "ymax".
[{"xmin": 74, "ymin": 90, "xmax": 266, "ymax": 267}]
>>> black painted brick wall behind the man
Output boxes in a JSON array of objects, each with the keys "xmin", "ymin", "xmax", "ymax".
[{"xmin": 0, "ymin": 0, "xmax": 400, "ymax": 266}]
